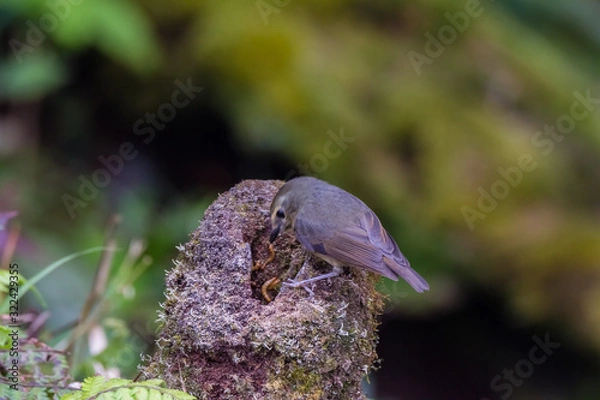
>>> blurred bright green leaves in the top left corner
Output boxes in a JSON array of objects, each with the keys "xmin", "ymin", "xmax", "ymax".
[{"xmin": 0, "ymin": 0, "xmax": 161, "ymax": 100}]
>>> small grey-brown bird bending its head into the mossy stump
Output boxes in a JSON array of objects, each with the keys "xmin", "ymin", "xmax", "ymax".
[{"xmin": 269, "ymin": 177, "xmax": 429, "ymax": 292}]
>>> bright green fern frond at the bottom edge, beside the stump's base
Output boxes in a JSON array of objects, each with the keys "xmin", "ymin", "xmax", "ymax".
[{"xmin": 61, "ymin": 376, "xmax": 195, "ymax": 400}]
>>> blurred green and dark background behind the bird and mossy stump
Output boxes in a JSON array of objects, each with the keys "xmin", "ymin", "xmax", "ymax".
[{"xmin": 0, "ymin": 0, "xmax": 600, "ymax": 400}]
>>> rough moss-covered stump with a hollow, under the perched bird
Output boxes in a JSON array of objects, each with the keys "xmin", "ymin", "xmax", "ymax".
[{"xmin": 143, "ymin": 180, "xmax": 383, "ymax": 400}]
